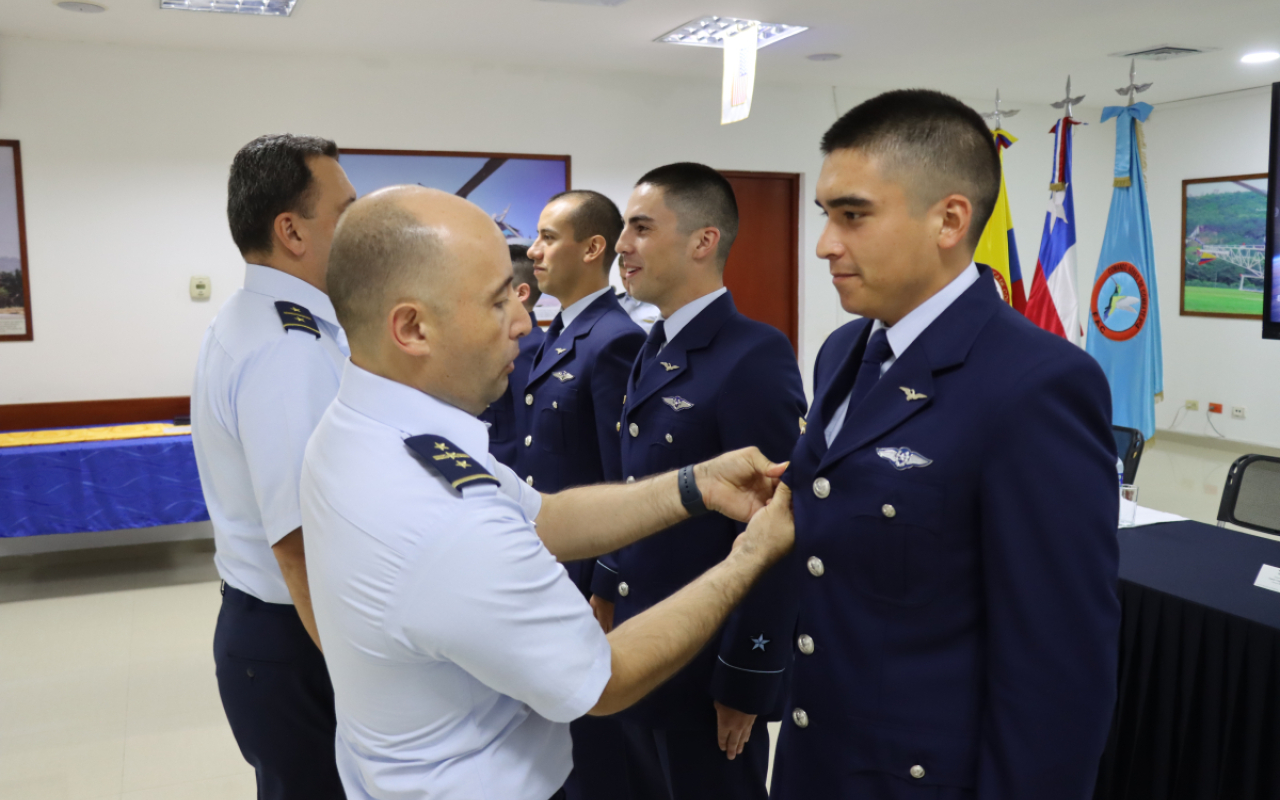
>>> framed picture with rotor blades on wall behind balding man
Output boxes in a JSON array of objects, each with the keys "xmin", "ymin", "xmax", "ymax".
[{"xmin": 342, "ymin": 147, "xmax": 571, "ymax": 324}]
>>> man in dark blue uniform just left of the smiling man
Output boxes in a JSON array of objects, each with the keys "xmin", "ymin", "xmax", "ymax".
[{"xmin": 516, "ymin": 191, "xmax": 644, "ymax": 800}]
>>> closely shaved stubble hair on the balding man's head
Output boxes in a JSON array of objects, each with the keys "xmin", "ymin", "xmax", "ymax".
[{"xmin": 326, "ymin": 200, "xmax": 449, "ymax": 340}]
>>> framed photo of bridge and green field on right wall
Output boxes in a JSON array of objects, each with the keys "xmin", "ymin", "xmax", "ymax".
[{"xmin": 1179, "ymin": 173, "xmax": 1267, "ymax": 320}]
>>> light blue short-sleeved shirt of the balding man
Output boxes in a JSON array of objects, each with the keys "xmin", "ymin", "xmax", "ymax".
[{"xmin": 302, "ymin": 361, "xmax": 612, "ymax": 800}]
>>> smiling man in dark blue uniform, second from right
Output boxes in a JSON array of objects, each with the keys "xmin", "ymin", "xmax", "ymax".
[{"xmin": 591, "ymin": 164, "xmax": 805, "ymax": 800}]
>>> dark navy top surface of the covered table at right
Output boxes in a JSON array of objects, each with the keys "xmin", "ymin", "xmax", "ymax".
[{"xmin": 1120, "ymin": 521, "xmax": 1280, "ymax": 628}]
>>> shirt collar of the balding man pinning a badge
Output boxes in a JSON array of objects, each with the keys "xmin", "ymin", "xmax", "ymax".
[{"xmin": 338, "ymin": 358, "xmax": 489, "ymax": 463}]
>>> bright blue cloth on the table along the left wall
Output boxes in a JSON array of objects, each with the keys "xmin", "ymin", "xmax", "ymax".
[{"xmin": 0, "ymin": 435, "xmax": 209, "ymax": 538}]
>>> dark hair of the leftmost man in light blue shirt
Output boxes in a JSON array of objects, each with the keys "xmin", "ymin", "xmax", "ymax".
[{"xmin": 227, "ymin": 133, "xmax": 338, "ymax": 255}]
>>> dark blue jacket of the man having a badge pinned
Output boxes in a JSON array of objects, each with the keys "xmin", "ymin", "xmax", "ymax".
[{"xmin": 773, "ymin": 268, "xmax": 1120, "ymax": 800}]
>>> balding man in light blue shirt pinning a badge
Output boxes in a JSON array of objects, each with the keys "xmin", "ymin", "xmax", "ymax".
[{"xmin": 301, "ymin": 187, "xmax": 795, "ymax": 800}]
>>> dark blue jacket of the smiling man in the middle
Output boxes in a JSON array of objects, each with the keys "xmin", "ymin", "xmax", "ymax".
[{"xmin": 591, "ymin": 293, "xmax": 805, "ymax": 730}]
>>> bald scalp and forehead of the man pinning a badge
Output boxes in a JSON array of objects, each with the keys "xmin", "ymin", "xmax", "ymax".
[{"xmin": 328, "ymin": 186, "xmax": 507, "ymax": 348}]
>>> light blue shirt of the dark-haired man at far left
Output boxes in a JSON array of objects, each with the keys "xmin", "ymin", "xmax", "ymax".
[{"xmin": 191, "ymin": 264, "xmax": 349, "ymax": 604}]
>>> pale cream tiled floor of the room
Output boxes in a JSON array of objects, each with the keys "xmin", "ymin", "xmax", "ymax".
[{"xmin": 0, "ymin": 436, "xmax": 1256, "ymax": 800}]
